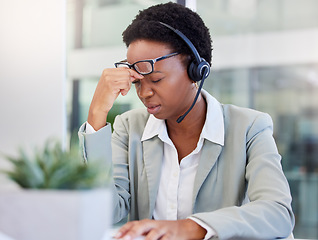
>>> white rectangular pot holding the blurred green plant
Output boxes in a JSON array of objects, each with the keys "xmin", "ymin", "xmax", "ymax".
[{"xmin": 0, "ymin": 189, "xmax": 112, "ymax": 240}]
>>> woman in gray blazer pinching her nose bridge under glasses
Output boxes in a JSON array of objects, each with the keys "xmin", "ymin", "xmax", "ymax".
[{"xmin": 79, "ymin": 3, "xmax": 294, "ymax": 239}]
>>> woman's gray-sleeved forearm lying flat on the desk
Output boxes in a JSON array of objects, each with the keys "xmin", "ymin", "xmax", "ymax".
[{"xmin": 192, "ymin": 201, "xmax": 294, "ymax": 239}]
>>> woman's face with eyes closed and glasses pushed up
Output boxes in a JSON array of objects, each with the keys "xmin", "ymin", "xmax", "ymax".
[{"xmin": 127, "ymin": 40, "xmax": 196, "ymax": 120}]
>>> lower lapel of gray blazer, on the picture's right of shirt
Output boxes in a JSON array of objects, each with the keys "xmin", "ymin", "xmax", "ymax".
[{"xmin": 192, "ymin": 140, "xmax": 222, "ymax": 209}]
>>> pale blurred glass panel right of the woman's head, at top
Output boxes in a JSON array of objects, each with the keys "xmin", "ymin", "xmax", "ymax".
[{"xmin": 197, "ymin": 0, "xmax": 318, "ymax": 35}]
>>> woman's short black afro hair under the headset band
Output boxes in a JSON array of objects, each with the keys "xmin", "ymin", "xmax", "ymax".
[{"xmin": 123, "ymin": 2, "xmax": 212, "ymax": 64}]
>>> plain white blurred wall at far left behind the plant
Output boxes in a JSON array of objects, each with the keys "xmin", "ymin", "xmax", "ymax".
[{"xmin": 0, "ymin": 0, "xmax": 67, "ymax": 188}]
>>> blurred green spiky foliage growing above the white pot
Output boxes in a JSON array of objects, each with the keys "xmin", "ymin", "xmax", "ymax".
[{"xmin": 3, "ymin": 140, "xmax": 112, "ymax": 189}]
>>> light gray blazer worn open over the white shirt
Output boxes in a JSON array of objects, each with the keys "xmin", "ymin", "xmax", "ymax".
[{"xmin": 79, "ymin": 98, "xmax": 294, "ymax": 239}]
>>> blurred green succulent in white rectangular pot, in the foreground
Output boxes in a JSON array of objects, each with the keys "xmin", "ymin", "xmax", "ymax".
[{"xmin": 0, "ymin": 141, "xmax": 112, "ymax": 240}]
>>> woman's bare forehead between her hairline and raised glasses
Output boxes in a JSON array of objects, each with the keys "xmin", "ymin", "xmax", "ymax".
[{"xmin": 127, "ymin": 40, "xmax": 172, "ymax": 63}]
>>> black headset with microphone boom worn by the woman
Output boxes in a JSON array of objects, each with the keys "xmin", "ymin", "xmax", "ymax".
[{"xmin": 159, "ymin": 22, "xmax": 211, "ymax": 123}]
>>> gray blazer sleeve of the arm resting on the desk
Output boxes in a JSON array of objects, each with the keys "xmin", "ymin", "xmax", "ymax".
[{"xmin": 192, "ymin": 114, "xmax": 294, "ymax": 239}]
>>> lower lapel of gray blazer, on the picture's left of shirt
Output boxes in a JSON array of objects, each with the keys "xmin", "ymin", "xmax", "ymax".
[{"xmin": 142, "ymin": 136, "xmax": 163, "ymax": 218}]
